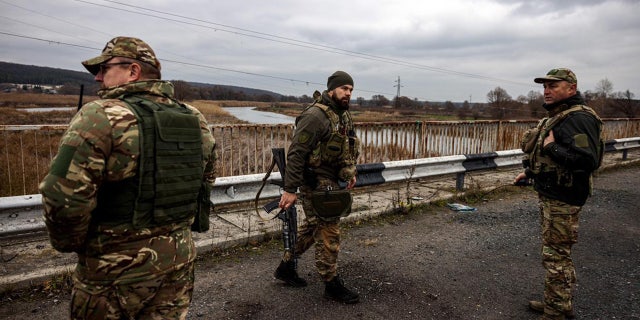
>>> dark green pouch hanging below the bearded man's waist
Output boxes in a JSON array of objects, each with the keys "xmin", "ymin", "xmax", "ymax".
[{"xmin": 311, "ymin": 190, "xmax": 353, "ymax": 221}]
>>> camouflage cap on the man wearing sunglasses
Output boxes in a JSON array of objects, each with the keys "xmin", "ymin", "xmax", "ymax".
[{"xmin": 82, "ymin": 37, "xmax": 160, "ymax": 75}]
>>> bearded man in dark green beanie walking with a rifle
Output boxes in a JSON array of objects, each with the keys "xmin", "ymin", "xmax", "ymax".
[{"xmin": 275, "ymin": 71, "xmax": 360, "ymax": 303}]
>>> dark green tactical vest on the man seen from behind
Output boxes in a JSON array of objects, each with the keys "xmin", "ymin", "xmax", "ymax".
[{"xmin": 92, "ymin": 96, "xmax": 204, "ymax": 229}]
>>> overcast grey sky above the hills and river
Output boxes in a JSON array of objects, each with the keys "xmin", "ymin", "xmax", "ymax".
[{"xmin": 0, "ymin": 0, "xmax": 640, "ymax": 102}]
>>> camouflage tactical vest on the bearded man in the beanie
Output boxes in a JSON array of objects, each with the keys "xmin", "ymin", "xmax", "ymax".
[{"xmin": 305, "ymin": 103, "xmax": 360, "ymax": 168}]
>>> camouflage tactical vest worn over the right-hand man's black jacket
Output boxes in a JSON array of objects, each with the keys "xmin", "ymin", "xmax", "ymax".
[{"xmin": 523, "ymin": 105, "xmax": 604, "ymax": 184}]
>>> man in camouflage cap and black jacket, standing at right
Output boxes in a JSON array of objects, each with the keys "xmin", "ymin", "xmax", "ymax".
[{"xmin": 514, "ymin": 68, "xmax": 604, "ymax": 319}]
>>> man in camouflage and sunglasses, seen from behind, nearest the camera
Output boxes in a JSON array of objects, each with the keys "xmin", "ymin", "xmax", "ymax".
[{"xmin": 40, "ymin": 37, "xmax": 216, "ymax": 319}]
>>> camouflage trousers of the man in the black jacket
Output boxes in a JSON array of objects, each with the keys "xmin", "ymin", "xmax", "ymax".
[{"xmin": 540, "ymin": 196, "xmax": 582, "ymax": 316}]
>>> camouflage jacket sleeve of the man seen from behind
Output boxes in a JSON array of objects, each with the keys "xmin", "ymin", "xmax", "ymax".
[{"xmin": 40, "ymin": 102, "xmax": 127, "ymax": 252}]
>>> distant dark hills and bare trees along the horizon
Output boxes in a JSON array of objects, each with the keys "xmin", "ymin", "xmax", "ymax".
[{"xmin": 0, "ymin": 62, "xmax": 640, "ymax": 120}]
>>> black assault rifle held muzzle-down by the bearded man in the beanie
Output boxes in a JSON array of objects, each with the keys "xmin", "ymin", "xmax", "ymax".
[{"xmin": 256, "ymin": 148, "xmax": 298, "ymax": 266}]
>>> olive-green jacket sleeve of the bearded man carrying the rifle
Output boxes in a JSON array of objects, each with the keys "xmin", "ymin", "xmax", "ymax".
[{"xmin": 284, "ymin": 107, "xmax": 331, "ymax": 193}]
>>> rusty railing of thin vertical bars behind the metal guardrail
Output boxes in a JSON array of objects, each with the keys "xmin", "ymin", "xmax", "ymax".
[{"xmin": 0, "ymin": 119, "xmax": 640, "ymax": 197}]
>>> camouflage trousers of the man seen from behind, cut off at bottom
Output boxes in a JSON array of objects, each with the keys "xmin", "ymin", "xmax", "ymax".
[{"xmin": 71, "ymin": 262, "xmax": 195, "ymax": 320}]
